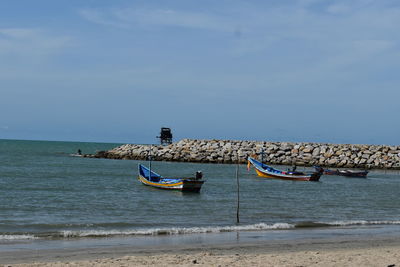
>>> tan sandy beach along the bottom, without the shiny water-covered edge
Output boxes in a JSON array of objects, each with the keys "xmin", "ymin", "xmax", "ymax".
[{"xmin": 0, "ymin": 237, "xmax": 400, "ymax": 267}]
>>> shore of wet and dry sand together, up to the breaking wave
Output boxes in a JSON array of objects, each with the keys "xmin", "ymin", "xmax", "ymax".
[{"xmin": 0, "ymin": 227, "xmax": 400, "ymax": 266}]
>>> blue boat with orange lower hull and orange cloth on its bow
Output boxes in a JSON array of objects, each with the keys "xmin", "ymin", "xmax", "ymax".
[{"xmin": 247, "ymin": 157, "xmax": 323, "ymax": 181}]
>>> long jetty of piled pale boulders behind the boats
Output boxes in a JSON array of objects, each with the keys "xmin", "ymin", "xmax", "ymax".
[{"xmin": 89, "ymin": 139, "xmax": 400, "ymax": 169}]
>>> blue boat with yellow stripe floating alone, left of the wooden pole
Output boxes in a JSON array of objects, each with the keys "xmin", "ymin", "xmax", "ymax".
[{"xmin": 138, "ymin": 164, "xmax": 204, "ymax": 192}]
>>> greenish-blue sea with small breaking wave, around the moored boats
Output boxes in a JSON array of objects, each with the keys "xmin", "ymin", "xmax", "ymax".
[{"xmin": 0, "ymin": 140, "xmax": 400, "ymax": 251}]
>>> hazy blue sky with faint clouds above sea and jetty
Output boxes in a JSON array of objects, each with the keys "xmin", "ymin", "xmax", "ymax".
[{"xmin": 0, "ymin": 0, "xmax": 400, "ymax": 145}]
